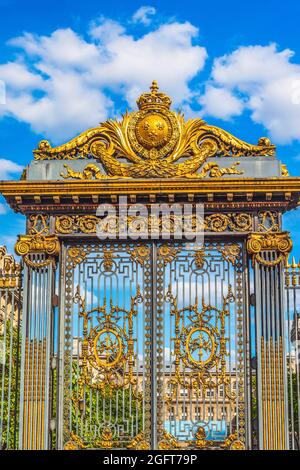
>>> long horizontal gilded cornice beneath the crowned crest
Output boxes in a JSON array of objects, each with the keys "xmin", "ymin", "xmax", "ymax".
[{"xmin": 0, "ymin": 177, "xmax": 300, "ymax": 197}]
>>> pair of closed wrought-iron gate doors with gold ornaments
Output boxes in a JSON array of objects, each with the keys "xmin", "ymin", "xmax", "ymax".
[{"xmin": 58, "ymin": 241, "xmax": 249, "ymax": 449}]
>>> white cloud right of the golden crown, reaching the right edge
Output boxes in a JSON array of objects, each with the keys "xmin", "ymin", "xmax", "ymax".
[{"xmin": 202, "ymin": 44, "xmax": 300, "ymax": 144}]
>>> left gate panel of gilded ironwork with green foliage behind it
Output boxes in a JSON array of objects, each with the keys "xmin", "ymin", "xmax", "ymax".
[{"xmin": 58, "ymin": 243, "xmax": 152, "ymax": 449}]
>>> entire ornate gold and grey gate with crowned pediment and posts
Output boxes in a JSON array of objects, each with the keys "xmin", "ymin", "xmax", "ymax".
[{"xmin": 0, "ymin": 82, "xmax": 300, "ymax": 449}]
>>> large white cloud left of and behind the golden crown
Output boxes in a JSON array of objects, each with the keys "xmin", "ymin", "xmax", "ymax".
[{"xmin": 0, "ymin": 17, "xmax": 207, "ymax": 143}]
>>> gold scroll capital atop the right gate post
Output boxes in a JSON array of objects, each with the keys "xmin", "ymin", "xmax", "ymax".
[{"xmin": 247, "ymin": 232, "xmax": 293, "ymax": 267}]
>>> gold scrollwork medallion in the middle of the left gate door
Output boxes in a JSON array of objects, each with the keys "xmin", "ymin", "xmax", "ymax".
[{"xmin": 74, "ymin": 286, "xmax": 143, "ymax": 402}]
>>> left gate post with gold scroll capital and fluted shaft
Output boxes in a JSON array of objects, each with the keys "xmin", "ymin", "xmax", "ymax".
[{"xmin": 15, "ymin": 234, "xmax": 60, "ymax": 450}]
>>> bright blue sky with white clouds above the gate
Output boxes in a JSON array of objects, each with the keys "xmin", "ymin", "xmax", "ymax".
[{"xmin": 0, "ymin": 0, "xmax": 300, "ymax": 256}]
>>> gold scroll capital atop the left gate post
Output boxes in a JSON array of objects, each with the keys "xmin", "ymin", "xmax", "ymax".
[{"xmin": 15, "ymin": 233, "xmax": 60, "ymax": 269}]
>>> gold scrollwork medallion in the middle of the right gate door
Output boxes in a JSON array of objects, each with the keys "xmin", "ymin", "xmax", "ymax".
[{"xmin": 165, "ymin": 285, "xmax": 235, "ymax": 403}]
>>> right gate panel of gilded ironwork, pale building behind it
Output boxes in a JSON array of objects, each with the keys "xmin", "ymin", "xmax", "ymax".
[{"xmin": 157, "ymin": 242, "xmax": 249, "ymax": 449}]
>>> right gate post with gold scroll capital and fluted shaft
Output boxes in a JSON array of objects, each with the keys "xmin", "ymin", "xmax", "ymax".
[{"xmin": 247, "ymin": 232, "xmax": 292, "ymax": 450}]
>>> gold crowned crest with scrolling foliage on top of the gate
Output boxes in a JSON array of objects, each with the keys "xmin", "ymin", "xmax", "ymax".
[{"xmin": 34, "ymin": 81, "xmax": 275, "ymax": 180}]
